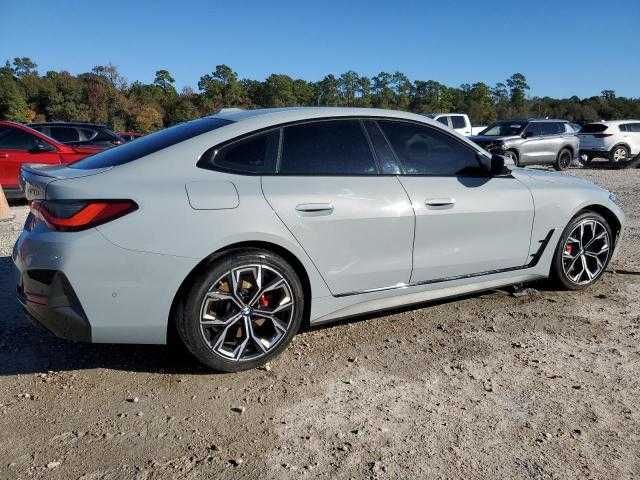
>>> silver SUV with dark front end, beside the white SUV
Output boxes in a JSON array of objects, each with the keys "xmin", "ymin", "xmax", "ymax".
[{"xmin": 469, "ymin": 119, "xmax": 579, "ymax": 170}]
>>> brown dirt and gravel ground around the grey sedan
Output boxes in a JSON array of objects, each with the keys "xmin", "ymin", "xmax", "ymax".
[{"xmin": 0, "ymin": 168, "xmax": 640, "ymax": 480}]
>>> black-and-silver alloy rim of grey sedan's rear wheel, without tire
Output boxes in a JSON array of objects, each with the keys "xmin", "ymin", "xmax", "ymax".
[{"xmin": 200, "ymin": 265, "xmax": 294, "ymax": 362}]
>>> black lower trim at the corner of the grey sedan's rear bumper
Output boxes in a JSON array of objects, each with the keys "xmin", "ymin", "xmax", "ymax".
[{"xmin": 16, "ymin": 268, "xmax": 91, "ymax": 342}]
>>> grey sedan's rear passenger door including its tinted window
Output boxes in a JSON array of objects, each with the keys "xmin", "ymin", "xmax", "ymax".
[{"xmin": 262, "ymin": 119, "xmax": 414, "ymax": 295}]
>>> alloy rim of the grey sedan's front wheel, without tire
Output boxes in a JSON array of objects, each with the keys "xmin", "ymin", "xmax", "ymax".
[{"xmin": 562, "ymin": 218, "xmax": 610, "ymax": 285}]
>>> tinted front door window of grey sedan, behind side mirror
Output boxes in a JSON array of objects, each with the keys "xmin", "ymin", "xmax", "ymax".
[{"xmin": 378, "ymin": 121, "xmax": 481, "ymax": 176}]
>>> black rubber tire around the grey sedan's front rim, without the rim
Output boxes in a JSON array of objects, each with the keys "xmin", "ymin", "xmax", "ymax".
[{"xmin": 551, "ymin": 211, "xmax": 614, "ymax": 290}]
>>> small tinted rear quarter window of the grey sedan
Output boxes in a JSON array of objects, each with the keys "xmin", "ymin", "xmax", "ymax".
[{"xmin": 212, "ymin": 130, "xmax": 280, "ymax": 173}]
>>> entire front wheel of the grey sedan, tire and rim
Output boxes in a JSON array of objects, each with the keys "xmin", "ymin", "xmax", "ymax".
[{"xmin": 552, "ymin": 212, "xmax": 613, "ymax": 290}]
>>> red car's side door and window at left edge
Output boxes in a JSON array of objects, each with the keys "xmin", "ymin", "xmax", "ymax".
[{"xmin": 0, "ymin": 127, "xmax": 60, "ymax": 188}]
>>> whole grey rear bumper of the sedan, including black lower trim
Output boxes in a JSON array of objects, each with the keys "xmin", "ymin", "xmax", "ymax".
[{"xmin": 13, "ymin": 223, "xmax": 198, "ymax": 344}]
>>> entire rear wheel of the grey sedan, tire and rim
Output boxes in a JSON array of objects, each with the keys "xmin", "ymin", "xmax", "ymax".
[{"xmin": 176, "ymin": 249, "xmax": 304, "ymax": 372}]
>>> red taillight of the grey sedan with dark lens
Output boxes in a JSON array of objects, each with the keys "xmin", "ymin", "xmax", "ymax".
[{"xmin": 31, "ymin": 200, "xmax": 138, "ymax": 232}]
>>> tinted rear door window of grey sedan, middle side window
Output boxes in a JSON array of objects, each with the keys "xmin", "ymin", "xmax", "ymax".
[{"xmin": 279, "ymin": 120, "xmax": 378, "ymax": 175}]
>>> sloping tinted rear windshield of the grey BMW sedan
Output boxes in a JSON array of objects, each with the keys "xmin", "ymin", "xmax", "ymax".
[{"xmin": 69, "ymin": 117, "xmax": 233, "ymax": 170}]
